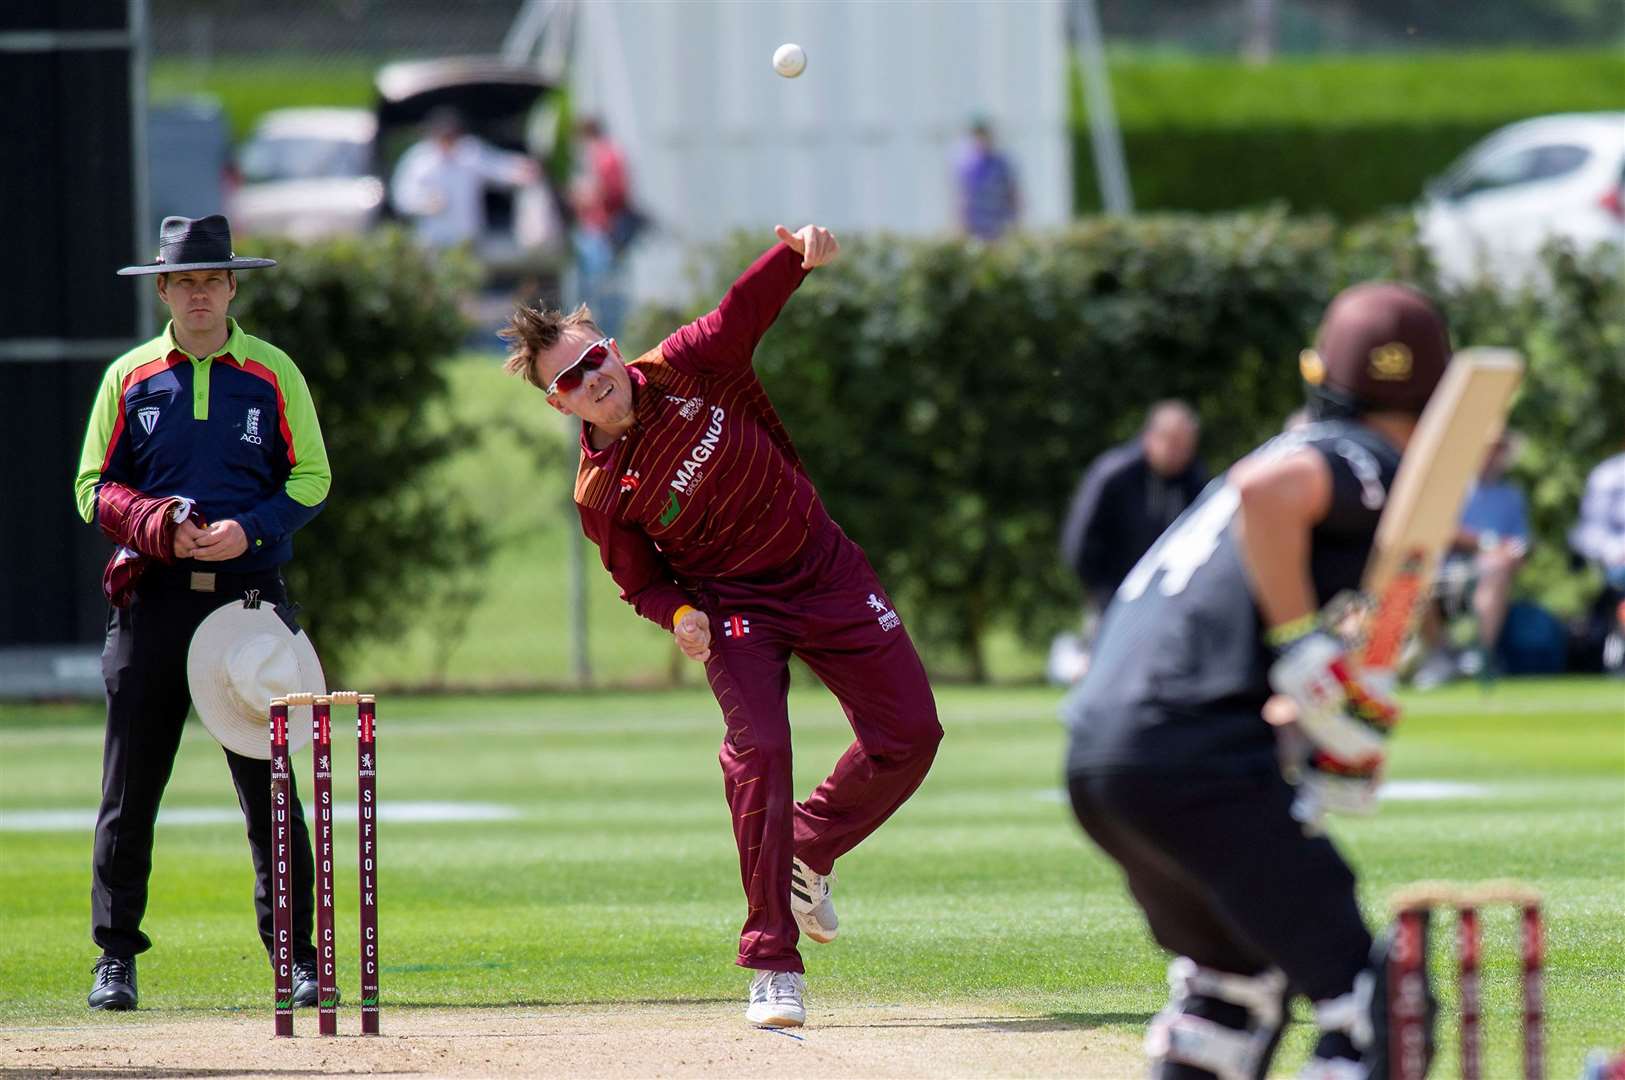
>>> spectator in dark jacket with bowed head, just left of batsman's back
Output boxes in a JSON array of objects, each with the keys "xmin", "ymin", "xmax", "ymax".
[{"xmin": 1061, "ymin": 401, "xmax": 1207, "ymax": 612}]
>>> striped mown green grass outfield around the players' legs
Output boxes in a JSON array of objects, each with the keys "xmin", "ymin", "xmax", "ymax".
[{"xmin": 0, "ymin": 680, "xmax": 1625, "ymax": 1077}]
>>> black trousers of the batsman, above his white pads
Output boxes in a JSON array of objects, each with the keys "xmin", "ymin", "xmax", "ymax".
[{"xmin": 1068, "ymin": 771, "xmax": 1372, "ymax": 1000}]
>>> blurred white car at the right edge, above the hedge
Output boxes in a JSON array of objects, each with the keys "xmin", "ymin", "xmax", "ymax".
[{"xmin": 1417, "ymin": 112, "xmax": 1625, "ymax": 286}]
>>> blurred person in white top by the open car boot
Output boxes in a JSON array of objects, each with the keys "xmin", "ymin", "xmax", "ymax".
[{"xmin": 390, "ymin": 106, "xmax": 541, "ymax": 250}]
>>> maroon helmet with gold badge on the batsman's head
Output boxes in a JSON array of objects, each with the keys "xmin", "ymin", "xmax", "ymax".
[{"xmin": 1298, "ymin": 281, "xmax": 1450, "ymax": 417}]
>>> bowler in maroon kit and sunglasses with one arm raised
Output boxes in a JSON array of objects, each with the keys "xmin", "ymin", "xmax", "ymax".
[{"xmin": 504, "ymin": 226, "xmax": 943, "ymax": 1026}]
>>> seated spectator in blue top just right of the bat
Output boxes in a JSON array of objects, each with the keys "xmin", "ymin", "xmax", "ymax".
[{"xmin": 1412, "ymin": 432, "xmax": 1529, "ymax": 690}]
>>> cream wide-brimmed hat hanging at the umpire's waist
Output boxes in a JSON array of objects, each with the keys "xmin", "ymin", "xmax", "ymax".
[{"xmin": 187, "ymin": 601, "xmax": 327, "ymax": 758}]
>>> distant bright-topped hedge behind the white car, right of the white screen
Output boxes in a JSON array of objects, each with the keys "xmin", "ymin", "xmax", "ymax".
[{"xmin": 1073, "ymin": 52, "xmax": 1625, "ymax": 221}]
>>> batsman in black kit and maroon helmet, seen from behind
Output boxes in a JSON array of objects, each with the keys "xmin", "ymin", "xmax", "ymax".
[{"xmin": 1064, "ymin": 283, "xmax": 1451, "ymax": 1080}]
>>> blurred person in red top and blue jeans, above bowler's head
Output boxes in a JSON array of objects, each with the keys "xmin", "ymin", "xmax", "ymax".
[{"xmin": 570, "ymin": 117, "xmax": 642, "ymax": 338}]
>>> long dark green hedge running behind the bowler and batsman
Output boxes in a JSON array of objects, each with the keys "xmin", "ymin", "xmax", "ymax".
[{"xmin": 650, "ymin": 213, "xmax": 1625, "ymax": 677}]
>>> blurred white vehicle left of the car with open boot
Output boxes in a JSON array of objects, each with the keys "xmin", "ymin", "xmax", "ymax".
[{"xmin": 229, "ymin": 109, "xmax": 384, "ymax": 240}]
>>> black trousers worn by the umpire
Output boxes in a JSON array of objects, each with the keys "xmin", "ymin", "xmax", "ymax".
[{"xmin": 91, "ymin": 567, "xmax": 315, "ymax": 960}]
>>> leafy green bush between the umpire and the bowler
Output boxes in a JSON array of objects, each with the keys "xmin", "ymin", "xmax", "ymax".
[{"xmin": 232, "ymin": 229, "xmax": 489, "ymax": 685}]
